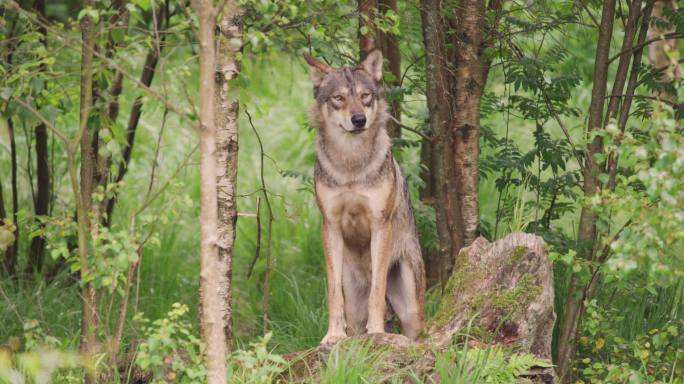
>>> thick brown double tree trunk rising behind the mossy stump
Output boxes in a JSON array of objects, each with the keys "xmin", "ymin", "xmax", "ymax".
[{"xmin": 420, "ymin": 0, "xmax": 502, "ymax": 285}]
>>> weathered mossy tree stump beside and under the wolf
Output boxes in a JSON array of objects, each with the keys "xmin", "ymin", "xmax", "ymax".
[{"xmin": 286, "ymin": 233, "xmax": 556, "ymax": 383}]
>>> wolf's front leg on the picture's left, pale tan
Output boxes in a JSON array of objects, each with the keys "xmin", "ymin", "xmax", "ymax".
[{"xmin": 321, "ymin": 219, "xmax": 347, "ymax": 344}]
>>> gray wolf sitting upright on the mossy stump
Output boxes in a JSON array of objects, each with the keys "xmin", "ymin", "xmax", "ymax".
[{"xmin": 305, "ymin": 50, "xmax": 425, "ymax": 344}]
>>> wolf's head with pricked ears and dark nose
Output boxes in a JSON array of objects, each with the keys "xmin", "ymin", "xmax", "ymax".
[{"xmin": 304, "ymin": 50, "xmax": 386, "ymax": 136}]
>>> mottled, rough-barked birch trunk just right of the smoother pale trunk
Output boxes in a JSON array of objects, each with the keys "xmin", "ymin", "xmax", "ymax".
[{"xmin": 214, "ymin": 1, "xmax": 243, "ymax": 352}]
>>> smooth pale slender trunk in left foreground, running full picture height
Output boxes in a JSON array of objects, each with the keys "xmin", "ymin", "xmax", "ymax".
[{"xmin": 192, "ymin": 0, "xmax": 229, "ymax": 384}]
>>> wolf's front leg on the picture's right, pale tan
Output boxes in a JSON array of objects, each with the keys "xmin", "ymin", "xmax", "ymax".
[{"xmin": 366, "ymin": 220, "xmax": 392, "ymax": 333}]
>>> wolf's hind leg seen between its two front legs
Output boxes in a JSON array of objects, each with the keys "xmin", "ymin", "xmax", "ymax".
[{"xmin": 342, "ymin": 258, "xmax": 370, "ymax": 335}]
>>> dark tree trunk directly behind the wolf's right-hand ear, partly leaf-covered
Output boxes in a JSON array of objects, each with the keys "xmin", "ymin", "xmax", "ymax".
[{"xmin": 378, "ymin": 0, "xmax": 401, "ymax": 138}]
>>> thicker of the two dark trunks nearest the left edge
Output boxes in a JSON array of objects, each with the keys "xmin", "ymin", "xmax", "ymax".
[{"xmin": 26, "ymin": 0, "xmax": 51, "ymax": 273}]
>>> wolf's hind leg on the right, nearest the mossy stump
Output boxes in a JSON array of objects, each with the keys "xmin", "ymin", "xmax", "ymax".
[{"xmin": 387, "ymin": 259, "xmax": 423, "ymax": 339}]
